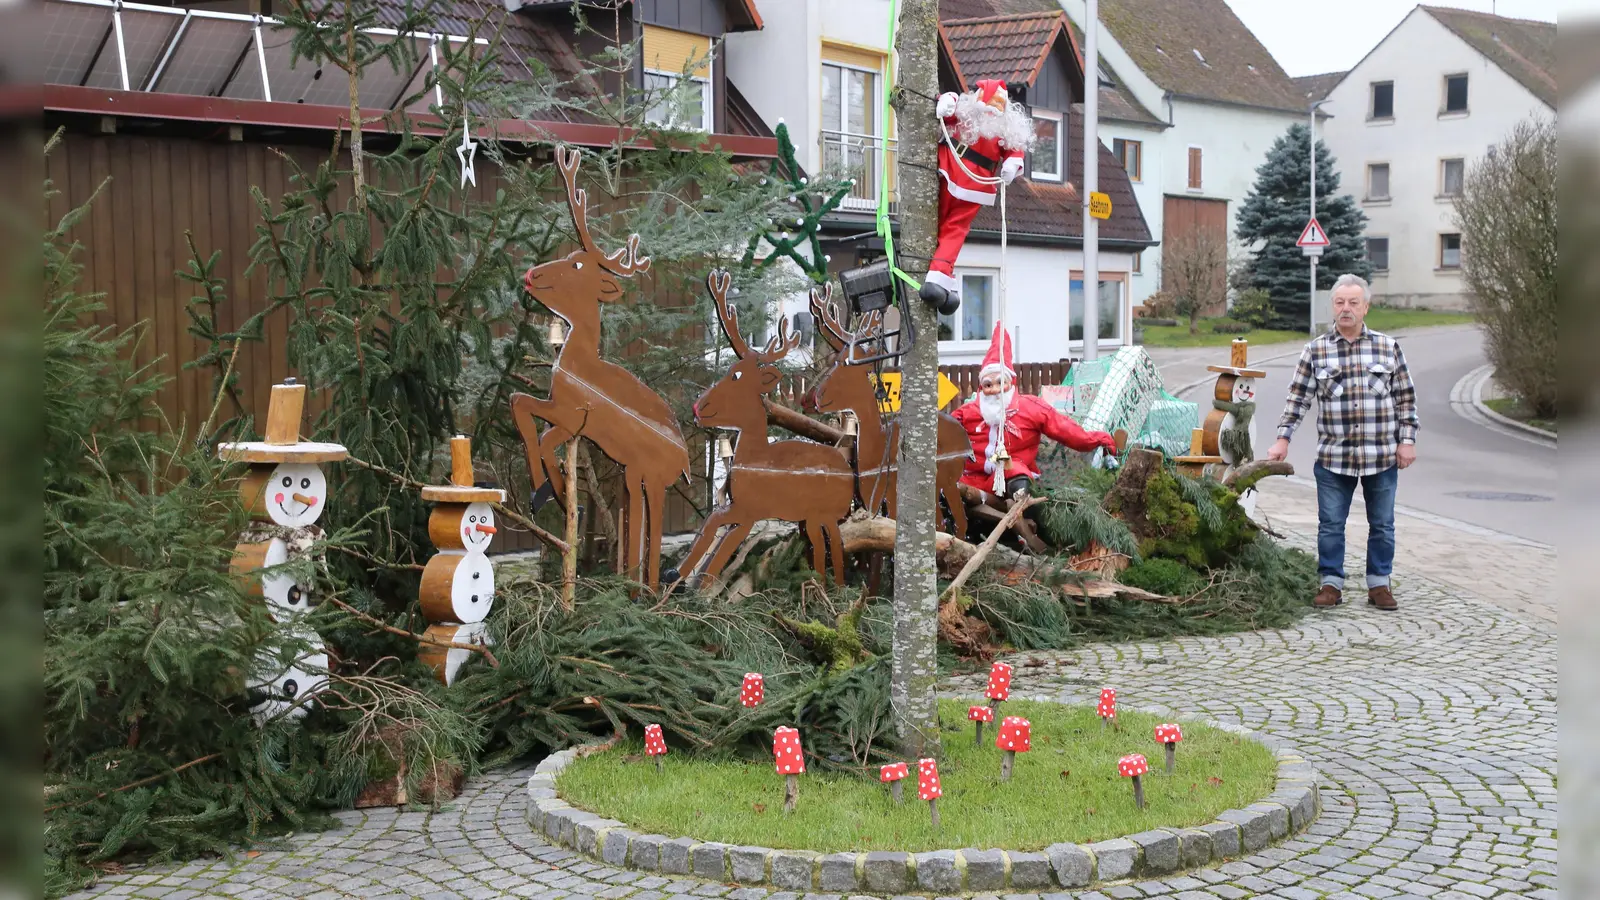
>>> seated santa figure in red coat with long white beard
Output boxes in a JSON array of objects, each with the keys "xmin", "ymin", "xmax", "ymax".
[{"xmin": 955, "ymin": 322, "xmax": 1117, "ymax": 498}]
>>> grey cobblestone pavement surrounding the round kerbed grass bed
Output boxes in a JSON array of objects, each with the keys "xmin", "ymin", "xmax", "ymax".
[{"xmin": 72, "ymin": 535, "xmax": 1557, "ymax": 900}]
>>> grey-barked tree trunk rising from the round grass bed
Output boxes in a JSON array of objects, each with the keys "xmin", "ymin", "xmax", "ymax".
[{"xmin": 890, "ymin": 0, "xmax": 939, "ymax": 759}]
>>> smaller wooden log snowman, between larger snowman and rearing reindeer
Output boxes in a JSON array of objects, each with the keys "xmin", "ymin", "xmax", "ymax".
[{"xmin": 418, "ymin": 434, "xmax": 506, "ymax": 685}]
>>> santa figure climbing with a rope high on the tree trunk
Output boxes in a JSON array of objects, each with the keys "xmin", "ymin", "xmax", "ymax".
[{"xmin": 920, "ymin": 80, "xmax": 1034, "ymax": 315}]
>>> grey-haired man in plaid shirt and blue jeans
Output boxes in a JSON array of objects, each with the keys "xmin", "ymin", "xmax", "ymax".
[{"xmin": 1267, "ymin": 275, "xmax": 1418, "ymax": 610}]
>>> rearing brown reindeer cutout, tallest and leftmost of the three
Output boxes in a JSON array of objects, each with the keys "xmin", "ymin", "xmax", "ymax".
[{"xmin": 510, "ymin": 147, "xmax": 690, "ymax": 586}]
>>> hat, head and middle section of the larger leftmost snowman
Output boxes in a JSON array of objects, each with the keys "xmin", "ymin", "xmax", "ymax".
[{"xmin": 216, "ymin": 378, "xmax": 350, "ymax": 613}]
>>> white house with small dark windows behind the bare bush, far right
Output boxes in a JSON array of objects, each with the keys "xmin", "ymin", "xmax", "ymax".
[{"xmin": 1322, "ymin": 6, "xmax": 1555, "ymax": 309}]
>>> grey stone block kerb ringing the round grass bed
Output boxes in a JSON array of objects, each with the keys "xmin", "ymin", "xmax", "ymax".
[{"xmin": 526, "ymin": 707, "xmax": 1320, "ymax": 895}]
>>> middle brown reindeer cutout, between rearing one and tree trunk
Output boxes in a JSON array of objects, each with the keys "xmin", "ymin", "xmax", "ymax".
[{"xmin": 668, "ymin": 269, "xmax": 856, "ymax": 585}]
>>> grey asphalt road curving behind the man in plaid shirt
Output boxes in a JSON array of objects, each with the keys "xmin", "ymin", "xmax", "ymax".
[{"xmin": 1184, "ymin": 325, "xmax": 1563, "ymax": 546}]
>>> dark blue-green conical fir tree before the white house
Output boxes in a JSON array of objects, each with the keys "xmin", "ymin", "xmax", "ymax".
[{"xmin": 1235, "ymin": 125, "xmax": 1373, "ymax": 328}]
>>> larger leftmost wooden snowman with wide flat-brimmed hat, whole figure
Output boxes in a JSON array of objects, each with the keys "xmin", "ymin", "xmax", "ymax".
[{"xmin": 216, "ymin": 378, "xmax": 350, "ymax": 724}]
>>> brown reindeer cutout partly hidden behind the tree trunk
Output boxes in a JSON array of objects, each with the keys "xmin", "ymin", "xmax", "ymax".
[{"xmin": 811, "ymin": 285, "xmax": 973, "ymax": 538}]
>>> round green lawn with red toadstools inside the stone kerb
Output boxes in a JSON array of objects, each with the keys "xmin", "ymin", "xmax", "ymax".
[{"xmin": 557, "ymin": 700, "xmax": 1277, "ymax": 852}]
